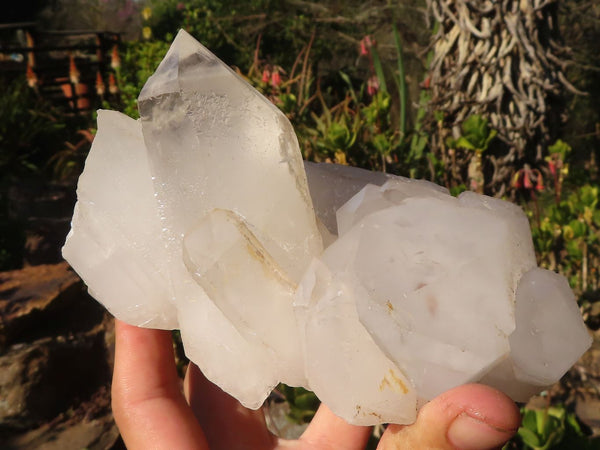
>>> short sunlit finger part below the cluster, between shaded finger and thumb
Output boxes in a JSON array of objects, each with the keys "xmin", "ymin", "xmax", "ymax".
[{"xmin": 300, "ymin": 403, "xmax": 371, "ymax": 450}]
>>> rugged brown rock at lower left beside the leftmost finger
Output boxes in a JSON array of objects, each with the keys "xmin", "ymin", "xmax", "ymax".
[{"xmin": 0, "ymin": 262, "xmax": 116, "ymax": 442}]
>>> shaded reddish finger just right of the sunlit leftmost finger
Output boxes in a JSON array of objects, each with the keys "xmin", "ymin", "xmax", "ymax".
[{"xmin": 184, "ymin": 363, "xmax": 276, "ymax": 450}]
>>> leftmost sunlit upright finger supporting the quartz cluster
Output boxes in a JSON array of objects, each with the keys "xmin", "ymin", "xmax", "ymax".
[{"xmin": 112, "ymin": 320, "xmax": 208, "ymax": 450}]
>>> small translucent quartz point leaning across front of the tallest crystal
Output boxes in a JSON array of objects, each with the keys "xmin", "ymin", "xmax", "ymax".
[{"xmin": 183, "ymin": 209, "xmax": 306, "ymax": 385}]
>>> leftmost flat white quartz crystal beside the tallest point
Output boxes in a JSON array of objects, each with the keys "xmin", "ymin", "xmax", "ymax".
[{"xmin": 63, "ymin": 111, "xmax": 177, "ymax": 329}]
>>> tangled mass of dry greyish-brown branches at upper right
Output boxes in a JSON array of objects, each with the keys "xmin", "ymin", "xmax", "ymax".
[{"xmin": 427, "ymin": 0, "xmax": 580, "ymax": 193}]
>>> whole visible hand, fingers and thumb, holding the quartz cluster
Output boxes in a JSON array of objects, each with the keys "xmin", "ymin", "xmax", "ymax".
[{"xmin": 112, "ymin": 320, "xmax": 520, "ymax": 450}]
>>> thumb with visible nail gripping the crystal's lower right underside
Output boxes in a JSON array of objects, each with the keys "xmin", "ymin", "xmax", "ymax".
[{"xmin": 378, "ymin": 384, "xmax": 520, "ymax": 450}]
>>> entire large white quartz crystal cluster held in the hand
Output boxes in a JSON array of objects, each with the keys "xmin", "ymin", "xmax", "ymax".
[{"xmin": 63, "ymin": 31, "xmax": 591, "ymax": 425}]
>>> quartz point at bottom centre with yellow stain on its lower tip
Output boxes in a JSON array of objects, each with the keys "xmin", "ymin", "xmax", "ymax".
[{"xmin": 295, "ymin": 260, "xmax": 417, "ymax": 425}]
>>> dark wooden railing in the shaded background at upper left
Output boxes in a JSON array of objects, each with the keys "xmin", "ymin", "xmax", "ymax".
[{"xmin": 0, "ymin": 23, "xmax": 121, "ymax": 113}]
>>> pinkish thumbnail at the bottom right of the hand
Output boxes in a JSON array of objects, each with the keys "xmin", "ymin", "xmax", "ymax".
[{"xmin": 448, "ymin": 413, "xmax": 512, "ymax": 450}]
